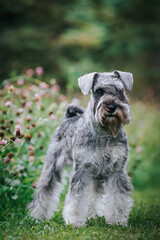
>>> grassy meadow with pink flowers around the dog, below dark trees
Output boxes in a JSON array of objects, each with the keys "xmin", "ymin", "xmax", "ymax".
[{"xmin": 0, "ymin": 78, "xmax": 160, "ymax": 240}]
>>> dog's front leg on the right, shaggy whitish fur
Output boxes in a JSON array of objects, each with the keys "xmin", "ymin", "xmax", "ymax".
[{"xmin": 104, "ymin": 174, "xmax": 133, "ymax": 226}]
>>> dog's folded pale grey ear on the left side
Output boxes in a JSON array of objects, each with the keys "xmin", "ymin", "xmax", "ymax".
[{"xmin": 78, "ymin": 72, "xmax": 97, "ymax": 95}]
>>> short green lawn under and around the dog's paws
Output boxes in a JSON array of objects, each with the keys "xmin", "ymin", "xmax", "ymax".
[{"xmin": 0, "ymin": 190, "xmax": 160, "ymax": 240}]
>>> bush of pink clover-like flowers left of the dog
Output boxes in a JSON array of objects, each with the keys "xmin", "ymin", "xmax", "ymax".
[{"xmin": 0, "ymin": 71, "xmax": 68, "ymax": 209}]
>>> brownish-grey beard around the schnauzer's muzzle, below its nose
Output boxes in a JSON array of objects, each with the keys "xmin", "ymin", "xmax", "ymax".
[{"xmin": 95, "ymin": 105, "xmax": 126, "ymax": 137}]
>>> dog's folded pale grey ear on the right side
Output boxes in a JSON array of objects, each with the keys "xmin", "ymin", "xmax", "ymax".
[{"xmin": 114, "ymin": 70, "xmax": 133, "ymax": 91}]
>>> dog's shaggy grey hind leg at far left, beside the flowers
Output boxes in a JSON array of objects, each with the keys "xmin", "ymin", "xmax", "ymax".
[{"xmin": 29, "ymin": 142, "xmax": 65, "ymax": 220}]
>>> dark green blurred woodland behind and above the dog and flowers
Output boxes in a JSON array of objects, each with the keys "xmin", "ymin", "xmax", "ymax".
[{"xmin": 0, "ymin": 0, "xmax": 160, "ymax": 98}]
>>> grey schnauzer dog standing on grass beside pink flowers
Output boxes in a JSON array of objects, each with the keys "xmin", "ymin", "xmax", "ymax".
[{"xmin": 29, "ymin": 70, "xmax": 133, "ymax": 227}]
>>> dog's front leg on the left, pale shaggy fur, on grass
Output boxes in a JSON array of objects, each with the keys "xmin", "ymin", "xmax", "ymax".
[{"xmin": 63, "ymin": 167, "xmax": 90, "ymax": 227}]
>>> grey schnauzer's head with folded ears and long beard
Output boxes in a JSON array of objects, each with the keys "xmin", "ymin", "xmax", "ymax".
[{"xmin": 78, "ymin": 70, "xmax": 133, "ymax": 137}]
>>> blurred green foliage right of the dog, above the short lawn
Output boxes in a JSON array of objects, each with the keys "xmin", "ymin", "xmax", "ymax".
[{"xmin": 128, "ymin": 102, "xmax": 160, "ymax": 189}]
